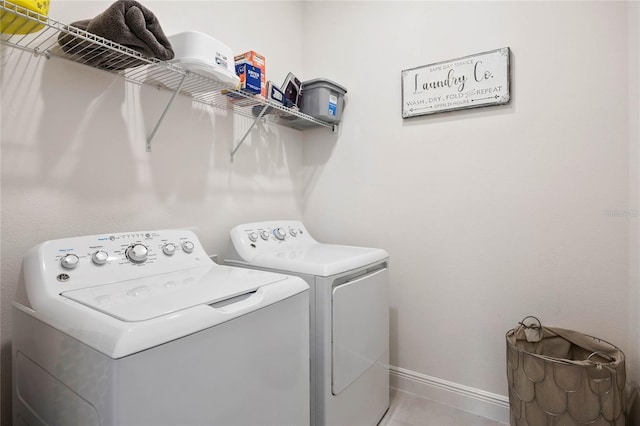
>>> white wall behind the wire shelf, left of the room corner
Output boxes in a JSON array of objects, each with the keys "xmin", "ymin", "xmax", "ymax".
[{"xmin": 1, "ymin": 1, "xmax": 302, "ymax": 424}]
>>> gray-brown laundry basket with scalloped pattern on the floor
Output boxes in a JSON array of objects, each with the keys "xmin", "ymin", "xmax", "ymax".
[{"xmin": 506, "ymin": 317, "xmax": 626, "ymax": 426}]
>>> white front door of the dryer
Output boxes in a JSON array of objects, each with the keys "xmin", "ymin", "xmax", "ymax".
[{"xmin": 331, "ymin": 267, "xmax": 389, "ymax": 395}]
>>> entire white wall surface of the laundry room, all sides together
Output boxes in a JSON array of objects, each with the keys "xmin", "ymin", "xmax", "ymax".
[{"xmin": 0, "ymin": 1, "xmax": 640, "ymax": 424}]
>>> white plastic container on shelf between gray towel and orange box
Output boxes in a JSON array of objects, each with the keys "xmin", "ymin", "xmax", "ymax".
[{"xmin": 169, "ymin": 31, "xmax": 240, "ymax": 89}]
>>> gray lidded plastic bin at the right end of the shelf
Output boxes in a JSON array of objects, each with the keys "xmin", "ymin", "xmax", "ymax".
[{"xmin": 300, "ymin": 78, "xmax": 347, "ymax": 124}]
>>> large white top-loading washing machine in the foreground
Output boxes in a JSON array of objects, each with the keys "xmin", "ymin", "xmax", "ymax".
[{"xmin": 12, "ymin": 230, "xmax": 310, "ymax": 426}]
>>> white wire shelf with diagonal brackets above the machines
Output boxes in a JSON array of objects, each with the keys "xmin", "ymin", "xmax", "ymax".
[{"xmin": 0, "ymin": 0, "xmax": 335, "ymax": 152}]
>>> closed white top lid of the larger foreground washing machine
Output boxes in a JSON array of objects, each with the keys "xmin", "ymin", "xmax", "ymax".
[{"xmin": 61, "ymin": 266, "xmax": 286, "ymax": 322}]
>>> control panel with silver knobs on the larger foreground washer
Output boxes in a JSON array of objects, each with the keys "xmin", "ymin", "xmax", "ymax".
[{"xmin": 23, "ymin": 229, "xmax": 213, "ymax": 294}]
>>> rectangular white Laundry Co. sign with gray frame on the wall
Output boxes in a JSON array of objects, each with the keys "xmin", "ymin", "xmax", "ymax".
[{"xmin": 402, "ymin": 47, "xmax": 511, "ymax": 118}]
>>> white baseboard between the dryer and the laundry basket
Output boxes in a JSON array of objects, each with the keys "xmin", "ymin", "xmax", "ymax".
[{"xmin": 389, "ymin": 365, "xmax": 509, "ymax": 424}]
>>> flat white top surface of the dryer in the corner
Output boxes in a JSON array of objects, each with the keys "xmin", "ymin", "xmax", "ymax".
[{"xmin": 248, "ymin": 243, "xmax": 389, "ymax": 277}]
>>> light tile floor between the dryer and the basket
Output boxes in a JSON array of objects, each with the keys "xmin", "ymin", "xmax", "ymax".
[{"xmin": 378, "ymin": 389, "xmax": 505, "ymax": 426}]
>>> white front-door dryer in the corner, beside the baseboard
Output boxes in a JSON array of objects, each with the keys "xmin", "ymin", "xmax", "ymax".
[{"xmin": 225, "ymin": 221, "xmax": 389, "ymax": 426}]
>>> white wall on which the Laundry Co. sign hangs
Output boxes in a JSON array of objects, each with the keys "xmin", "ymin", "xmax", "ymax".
[{"xmin": 304, "ymin": 2, "xmax": 638, "ymax": 418}]
